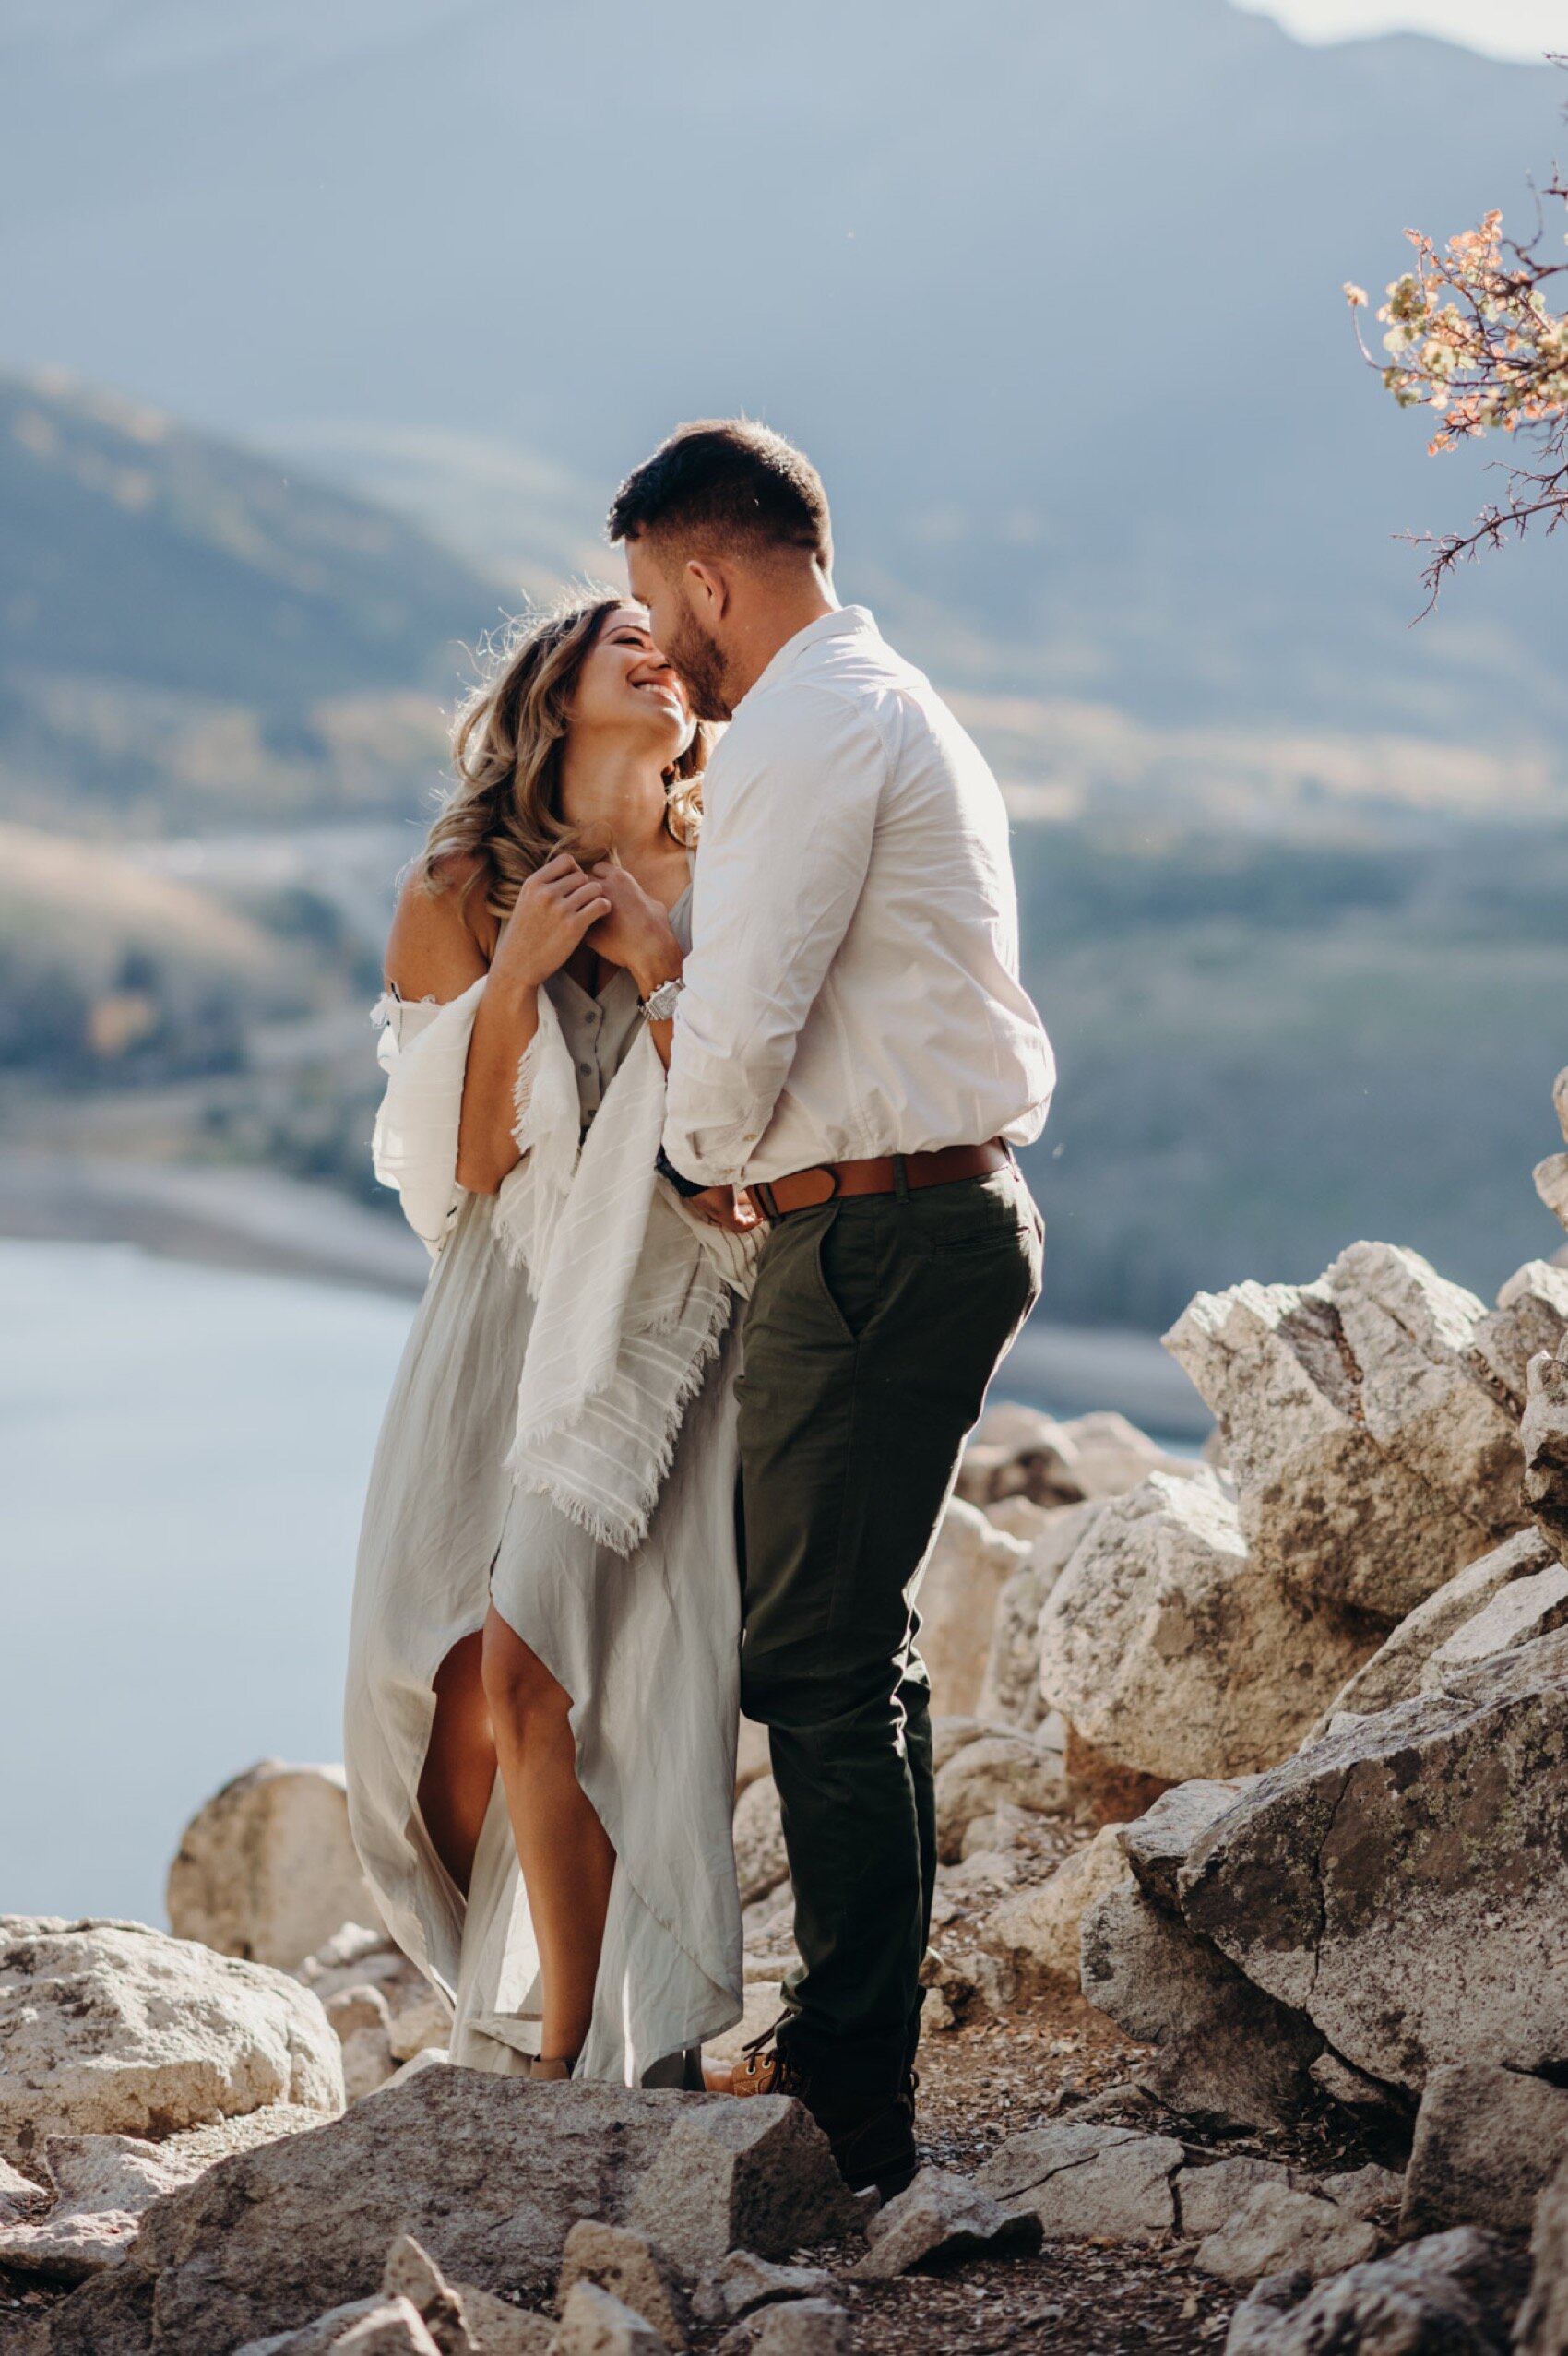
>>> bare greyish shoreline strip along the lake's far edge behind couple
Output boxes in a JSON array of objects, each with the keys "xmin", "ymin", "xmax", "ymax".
[{"xmin": 0, "ymin": 1152, "xmax": 1213, "ymax": 1439}]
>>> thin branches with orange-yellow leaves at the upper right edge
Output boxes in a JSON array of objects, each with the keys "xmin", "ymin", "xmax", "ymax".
[{"xmin": 1345, "ymin": 85, "xmax": 1568, "ymax": 613}]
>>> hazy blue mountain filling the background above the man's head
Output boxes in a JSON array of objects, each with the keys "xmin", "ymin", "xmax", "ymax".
[{"xmin": 0, "ymin": 0, "xmax": 1568, "ymax": 758}]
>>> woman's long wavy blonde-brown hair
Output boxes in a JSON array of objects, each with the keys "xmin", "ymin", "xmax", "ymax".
[{"xmin": 419, "ymin": 584, "xmax": 708, "ymax": 919}]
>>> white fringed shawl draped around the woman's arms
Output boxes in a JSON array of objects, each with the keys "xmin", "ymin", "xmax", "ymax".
[{"xmin": 374, "ymin": 978, "xmax": 760, "ymax": 1555}]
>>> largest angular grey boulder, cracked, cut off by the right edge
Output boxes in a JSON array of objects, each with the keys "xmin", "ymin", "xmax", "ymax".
[{"xmin": 1180, "ymin": 1630, "xmax": 1568, "ymax": 2089}]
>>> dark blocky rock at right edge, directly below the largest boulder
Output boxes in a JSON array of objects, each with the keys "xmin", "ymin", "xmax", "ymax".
[{"xmin": 1398, "ymin": 2062, "xmax": 1568, "ymax": 2241}]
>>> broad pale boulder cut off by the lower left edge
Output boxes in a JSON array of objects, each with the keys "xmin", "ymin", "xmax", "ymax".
[{"xmin": 0, "ymin": 1915, "xmax": 344, "ymax": 2158}]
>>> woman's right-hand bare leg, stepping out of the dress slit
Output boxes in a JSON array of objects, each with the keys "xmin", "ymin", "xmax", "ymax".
[{"xmin": 482, "ymin": 1607, "xmax": 614, "ymax": 2062}]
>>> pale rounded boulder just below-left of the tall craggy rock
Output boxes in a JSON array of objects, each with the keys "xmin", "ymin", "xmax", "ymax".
[{"xmin": 1040, "ymin": 1470, "xmax": 1368, "ymax": 1781}]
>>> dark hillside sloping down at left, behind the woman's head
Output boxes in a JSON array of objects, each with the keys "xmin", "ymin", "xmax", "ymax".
[{"xmin": 0, "ymin": 375, "xmax": 502, "ymax": 834}]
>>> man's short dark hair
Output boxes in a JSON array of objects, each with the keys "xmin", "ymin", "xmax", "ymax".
[{"xmin": 608, "ymin": 417, "xmax": 834, "ymax": 573}]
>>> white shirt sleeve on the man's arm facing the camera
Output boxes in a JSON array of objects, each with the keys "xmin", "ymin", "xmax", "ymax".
[{"xmin": 664, "ymin": 684, "xmax": 887, "ymax": 1185}]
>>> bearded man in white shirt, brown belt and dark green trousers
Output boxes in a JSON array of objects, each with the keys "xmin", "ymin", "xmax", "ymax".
[{"xmin": 610, "ymin": 422, "xmax": 1055, "ymax": 2194}]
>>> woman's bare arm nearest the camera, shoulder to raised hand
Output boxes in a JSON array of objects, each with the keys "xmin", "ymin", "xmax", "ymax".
[{"xmin": 386, "ymin": 853, "xmax": 610, "ymax": 1195}]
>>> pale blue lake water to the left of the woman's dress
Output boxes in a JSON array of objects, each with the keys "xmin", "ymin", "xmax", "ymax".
[{"xmin": 0, "ymin": 1242, "xmax": 412, "ymax": 1922}]
